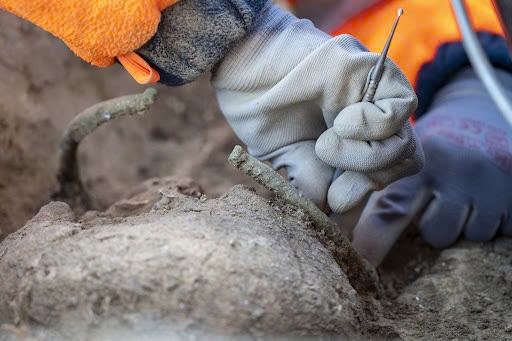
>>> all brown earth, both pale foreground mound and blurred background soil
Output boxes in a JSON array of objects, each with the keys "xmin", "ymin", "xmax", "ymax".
[{"xmin": 0, "ymin": 8, "xmax": 512, "ymax": 340}]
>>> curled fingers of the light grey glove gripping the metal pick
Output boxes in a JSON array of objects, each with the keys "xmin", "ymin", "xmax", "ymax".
[{"xmin": 316, "ymin": 117, "xmax": 424, "ymax": 213}]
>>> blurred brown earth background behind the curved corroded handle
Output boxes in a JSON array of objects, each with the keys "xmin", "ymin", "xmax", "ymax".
[{"xmin": 0, "ymin": 9, "xmax": 256, "ymax": 240}]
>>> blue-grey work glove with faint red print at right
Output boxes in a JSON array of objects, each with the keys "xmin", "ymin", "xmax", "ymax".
[{"xmin": 353, "ymin": 68, "xmax": 512, "ymax": 266}]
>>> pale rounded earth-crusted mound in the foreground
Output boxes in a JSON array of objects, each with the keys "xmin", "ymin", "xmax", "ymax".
[{"xmin": 0, "ymin": 184, "xmax": 365, "ymax": 339}]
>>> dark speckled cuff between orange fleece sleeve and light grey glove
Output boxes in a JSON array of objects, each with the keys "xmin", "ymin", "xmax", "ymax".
[{"xmin": 137, "ymin": 0, "xmax": 271, "ymax": 86}]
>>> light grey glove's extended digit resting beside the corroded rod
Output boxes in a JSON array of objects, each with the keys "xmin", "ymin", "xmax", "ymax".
[{"xmin": 264, "ymin": 140, "xmax": 334, "ymax": 209}]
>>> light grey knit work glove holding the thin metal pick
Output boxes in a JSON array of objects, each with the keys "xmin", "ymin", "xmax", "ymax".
[{"xmin": 212, "ymin": 3, "xmax": 422, "ymax": 212}]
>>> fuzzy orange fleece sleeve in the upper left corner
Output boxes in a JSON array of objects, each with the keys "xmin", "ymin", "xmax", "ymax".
[{"xmin": 0, "ymin": 0, "xmax": 179, "ymax": 66}]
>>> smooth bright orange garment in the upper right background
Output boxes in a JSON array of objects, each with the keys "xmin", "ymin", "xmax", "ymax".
[{"xmin": 332, "ymin": 0, "xmax": 503, "ymax": 87}]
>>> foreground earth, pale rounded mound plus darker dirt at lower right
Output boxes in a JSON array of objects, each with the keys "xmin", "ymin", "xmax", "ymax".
[{"xmin": 0, "ymin": 185, "xmax": 512, "ymax": 340}]
